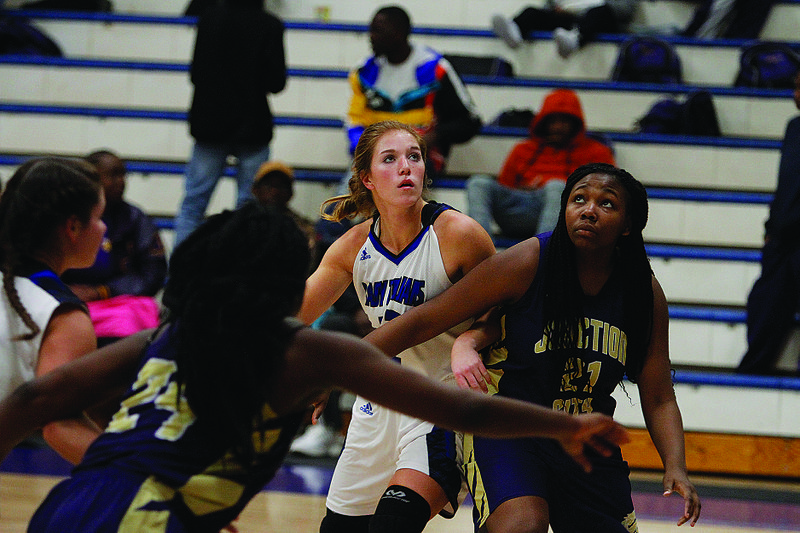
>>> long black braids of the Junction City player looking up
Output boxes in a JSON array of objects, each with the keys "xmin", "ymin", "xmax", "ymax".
[{"xmin": 542, "ymin": 163, "xmax": 653, "ymax": 381}]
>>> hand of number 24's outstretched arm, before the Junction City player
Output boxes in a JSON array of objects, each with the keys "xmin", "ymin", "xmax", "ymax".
[{"xmin": 559, "ymin": 413, "xmax": 630, "ymax": 472}]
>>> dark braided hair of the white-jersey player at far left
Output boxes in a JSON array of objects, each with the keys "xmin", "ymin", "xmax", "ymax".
[{"xmin": 0, "ymin": 157, "xmax": 102, "ymax": 340}]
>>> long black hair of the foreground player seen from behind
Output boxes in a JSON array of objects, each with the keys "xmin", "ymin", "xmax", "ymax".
[{"xmin": 163, "ymin": 202, "xmax": 310, "ymax": 465}]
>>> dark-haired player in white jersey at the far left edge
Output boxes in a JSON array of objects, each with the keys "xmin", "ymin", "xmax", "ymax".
[{"xmin": 0, "ymin": 157, "xmax": 108, "ymax": 463}]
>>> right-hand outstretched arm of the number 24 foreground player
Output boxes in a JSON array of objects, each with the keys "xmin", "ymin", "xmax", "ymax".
[{"xmin": 290, "ymin": 330, "xmax": 628, "ymax": 468}]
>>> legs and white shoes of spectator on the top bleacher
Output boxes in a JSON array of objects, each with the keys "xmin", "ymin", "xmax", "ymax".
[{"xmin": 492, "ymin": 0, "xmax": 641, "ymax": 58}]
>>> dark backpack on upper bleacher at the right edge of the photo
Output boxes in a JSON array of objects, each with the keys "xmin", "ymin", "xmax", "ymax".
[{"xmin": 734, "ymin": 42, "xmax": 800, "ymax": 89}]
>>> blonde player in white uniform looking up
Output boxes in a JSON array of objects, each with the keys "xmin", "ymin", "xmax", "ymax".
[{"xmin": 299, "ymin": 121, "xmax": 495, "ymax": 533}]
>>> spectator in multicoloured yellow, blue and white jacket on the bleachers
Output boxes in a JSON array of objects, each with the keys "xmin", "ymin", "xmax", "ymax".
[{"xmin": 341, "ymin": 6, "xmax": 481, "ymax": 183}]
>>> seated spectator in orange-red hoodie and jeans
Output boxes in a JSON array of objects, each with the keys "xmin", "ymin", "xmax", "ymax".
[{"xmin": 467, "ymin": 89, "xmax": 615, "ymax": 239}]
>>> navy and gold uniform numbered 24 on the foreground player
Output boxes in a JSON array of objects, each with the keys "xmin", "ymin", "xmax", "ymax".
[{"xmin": 30, "ymin": 322, "xmax": 304, "ymax": 533}]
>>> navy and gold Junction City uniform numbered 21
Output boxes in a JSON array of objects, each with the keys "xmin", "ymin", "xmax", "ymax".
[{"xmin": 464, "ymin": 233, "xmax": 638, "ymax": 533}]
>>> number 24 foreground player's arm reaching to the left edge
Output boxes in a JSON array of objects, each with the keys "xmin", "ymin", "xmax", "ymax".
[{"xmin": 0, "ymin": 330, "xmax": 154, "ymax": 459}]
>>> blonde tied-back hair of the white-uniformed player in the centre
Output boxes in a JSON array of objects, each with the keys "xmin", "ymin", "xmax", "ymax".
[{"xmin": 320, "ymin": 120, "xmax": 428, "ymax": 222}]
